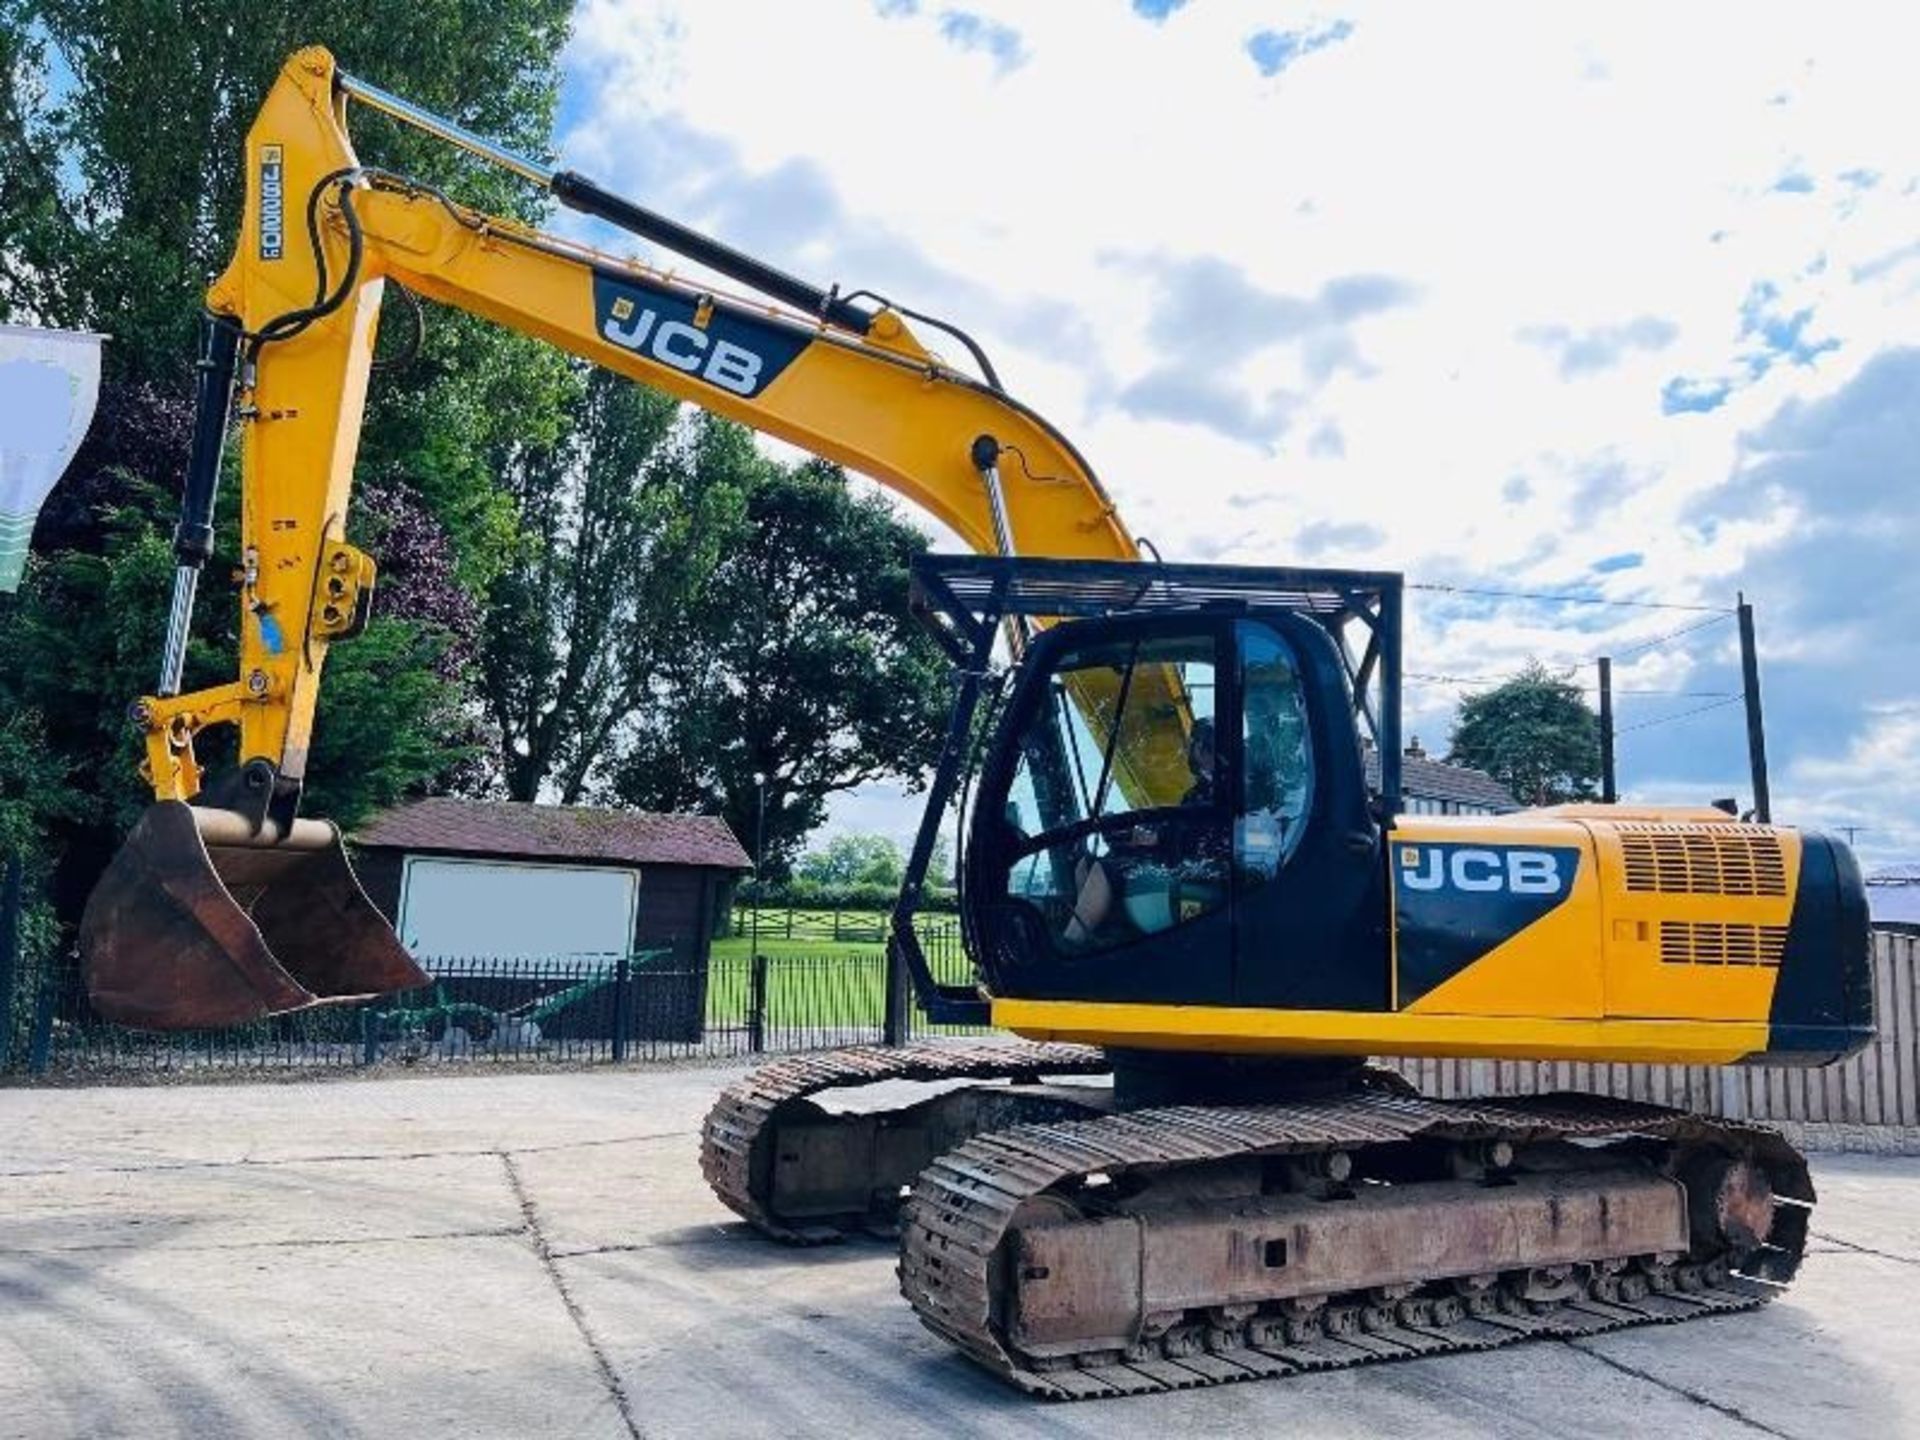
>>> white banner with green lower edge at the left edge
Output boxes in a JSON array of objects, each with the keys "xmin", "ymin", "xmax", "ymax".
[{"xmin": 0, "ymin": 324, "xmax": 102, "ymax": 593}]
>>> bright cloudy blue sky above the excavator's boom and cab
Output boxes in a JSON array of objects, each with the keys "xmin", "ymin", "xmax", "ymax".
[{"xmin": 561, "ymin": 0, "xmax": 1920, "ymax": 862}]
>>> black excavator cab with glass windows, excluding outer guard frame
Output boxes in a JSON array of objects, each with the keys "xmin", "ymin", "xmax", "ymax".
[{"xmin": 968, "ymin": 609, "xmax": 1386, "ymax": 1008}]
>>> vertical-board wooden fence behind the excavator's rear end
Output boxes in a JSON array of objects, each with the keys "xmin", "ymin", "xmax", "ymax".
[{"xmin": 1388, "ymin": 931, "xmax": 1920, "ymax": 1125}]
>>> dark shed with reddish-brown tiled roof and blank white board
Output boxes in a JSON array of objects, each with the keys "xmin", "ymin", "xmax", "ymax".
[{"xmin": 351, "ymin": 799, "xmax": 751, "ymax": 970}]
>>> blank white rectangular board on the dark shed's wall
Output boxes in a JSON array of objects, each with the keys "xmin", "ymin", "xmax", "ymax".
[{"xmin": 399, "ymin": 856, "xmax": 639, "ymax": 958}]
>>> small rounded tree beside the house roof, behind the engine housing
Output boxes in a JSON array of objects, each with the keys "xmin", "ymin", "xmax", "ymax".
[{"xmin": 1448, "ymin": 660, "xmax": 1599, "ymax": 804}]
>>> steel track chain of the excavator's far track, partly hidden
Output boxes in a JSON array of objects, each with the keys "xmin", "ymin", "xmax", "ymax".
[{"xmin": 701, "ymin": 1041, "xmax": 1110, "ymax": 1244}]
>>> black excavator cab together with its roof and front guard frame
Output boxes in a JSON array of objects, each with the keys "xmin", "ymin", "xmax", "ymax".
[{"xmin": 895, "ymin": 557, "xmax": 1400, "ymax": 1029}]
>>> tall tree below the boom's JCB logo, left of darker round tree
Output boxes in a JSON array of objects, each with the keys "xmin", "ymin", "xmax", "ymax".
[{"xmin": 480, "ymin": 371, "xmax": 745, "ymax": 804}]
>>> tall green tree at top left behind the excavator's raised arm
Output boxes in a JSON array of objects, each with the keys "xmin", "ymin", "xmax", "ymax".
[{"xmin": 0, "ymin": 0, "xmax": 578, "ymax": 589}]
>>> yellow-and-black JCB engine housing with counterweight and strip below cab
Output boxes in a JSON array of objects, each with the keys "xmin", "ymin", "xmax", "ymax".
[{"xmin": 993, "ymin": 806, "xmax": 1874, "ymax": 1064}]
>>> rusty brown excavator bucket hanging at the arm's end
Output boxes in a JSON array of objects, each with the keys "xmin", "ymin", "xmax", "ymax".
[{"xmin": 81, "ymin": 801, "xmax": 428, "ymax": 1029}]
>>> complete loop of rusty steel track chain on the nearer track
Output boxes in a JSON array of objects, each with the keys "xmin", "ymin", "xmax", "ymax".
[{"xmin": 900, "ymin": 1092, "xmax": 1812, "ymax": 1400}]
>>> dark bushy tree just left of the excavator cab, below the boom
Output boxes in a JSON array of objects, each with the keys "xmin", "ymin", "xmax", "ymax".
[{"xmin": 607, "ymin": 433, "xmax": 948, "ymax": 877}]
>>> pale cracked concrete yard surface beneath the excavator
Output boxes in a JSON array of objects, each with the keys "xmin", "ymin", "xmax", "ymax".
[{"xmin": 0, "ymin": 1068, "xmax": 1920, "ymax": 1440}]
